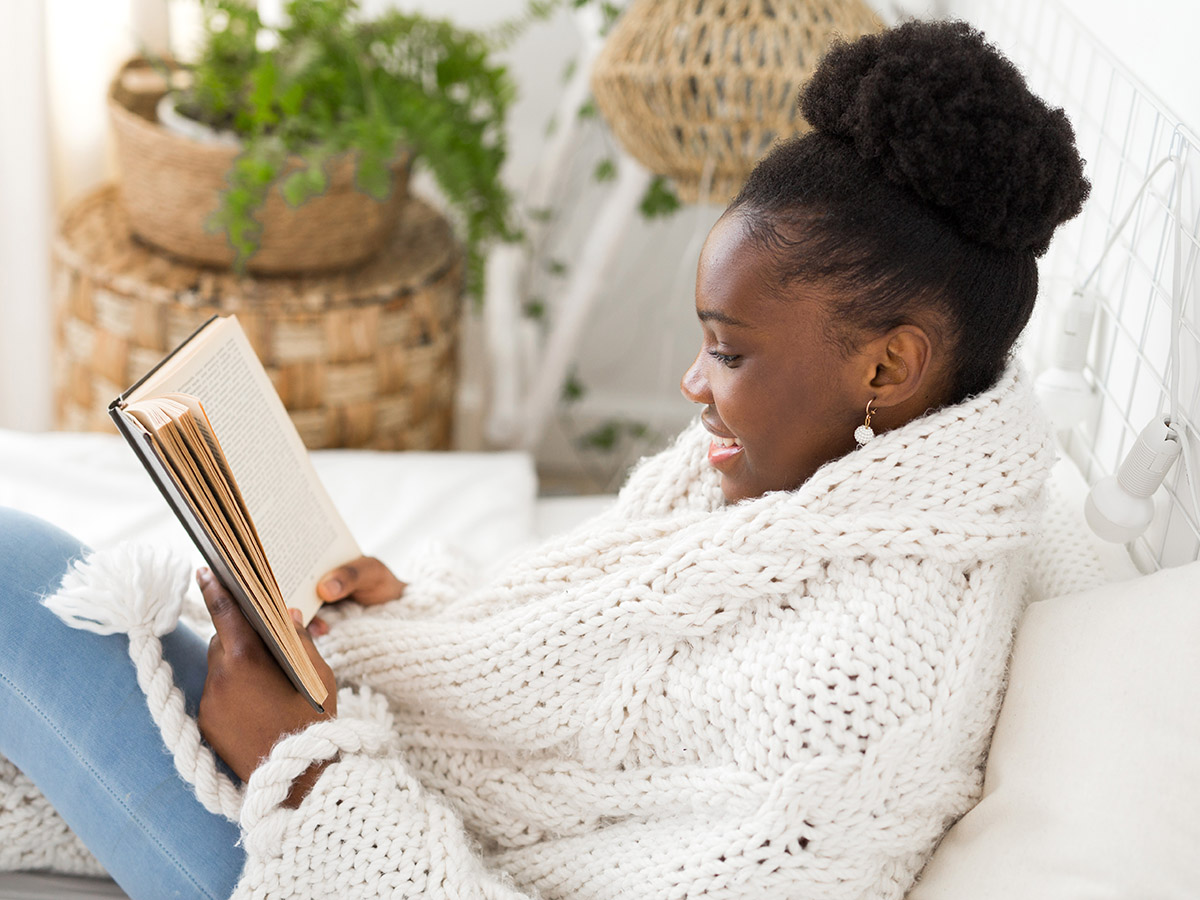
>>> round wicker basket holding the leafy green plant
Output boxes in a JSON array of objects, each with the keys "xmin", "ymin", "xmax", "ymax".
[{"xmin": 108, "ymin": 59, "xmax": 410, "ymax": 275}]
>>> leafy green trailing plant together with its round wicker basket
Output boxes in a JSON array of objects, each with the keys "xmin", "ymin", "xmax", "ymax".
[{"xmin": 110, "ymin": 0, "xmax": 514, "ymax": 294}]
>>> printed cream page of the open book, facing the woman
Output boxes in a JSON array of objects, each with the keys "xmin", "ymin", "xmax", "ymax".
[{"xmin": 128, "ymin": 317, "xmax": 360, "ymax": 620}]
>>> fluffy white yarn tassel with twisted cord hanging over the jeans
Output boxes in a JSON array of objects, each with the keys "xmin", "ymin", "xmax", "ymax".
[{"xmin": 44, "ymin": 545, "xmax": 242, "ymax": 821}]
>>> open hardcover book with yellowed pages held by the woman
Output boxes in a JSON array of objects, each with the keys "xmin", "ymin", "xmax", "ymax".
[{"xmin": 109, "ymin": 316, "xmax": 361, "ymax": 709}]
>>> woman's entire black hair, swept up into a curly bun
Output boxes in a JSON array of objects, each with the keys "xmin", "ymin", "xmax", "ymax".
[{"xmin": 730, "ymin": 22, "xmax": 1090, "ymax": 402}]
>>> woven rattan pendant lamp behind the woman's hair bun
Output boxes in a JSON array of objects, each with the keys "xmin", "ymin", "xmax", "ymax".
[{"xmin": 592, "ymin": 0, "xmax": 882, "ymax": 204}]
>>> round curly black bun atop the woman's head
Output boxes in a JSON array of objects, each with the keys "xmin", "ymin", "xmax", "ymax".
[{"xmin": 799, "ymin": 22, "xmax": 1090, "ymax": 256}]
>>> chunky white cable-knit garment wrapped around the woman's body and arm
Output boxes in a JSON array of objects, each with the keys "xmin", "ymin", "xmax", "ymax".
[{"xmin": 4, "ymin": 364, "xmax": 1052, "ymax": 900}]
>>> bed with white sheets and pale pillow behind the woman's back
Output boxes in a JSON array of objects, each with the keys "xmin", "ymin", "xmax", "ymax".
[{"xmin": 0, "ymin": 431, "xmax": 1200, "ymax": 900}]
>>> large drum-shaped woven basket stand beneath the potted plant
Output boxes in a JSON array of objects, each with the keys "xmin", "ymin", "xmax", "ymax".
[{"xmin": 54, "ymin": 186, "xmax": 463, "ymax": 450}]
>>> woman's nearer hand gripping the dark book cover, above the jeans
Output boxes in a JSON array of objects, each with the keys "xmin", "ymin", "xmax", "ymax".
[{"xmin": 196, "ymin": 569, "xmax": 337, "ymax": 804}]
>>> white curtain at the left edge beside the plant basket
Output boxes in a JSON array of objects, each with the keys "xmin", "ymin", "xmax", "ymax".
[{"xmin": 0, "ymin": 0, "xmax": 167, "ymax": 431}]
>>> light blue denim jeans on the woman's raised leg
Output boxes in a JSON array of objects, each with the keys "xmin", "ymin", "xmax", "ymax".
[{"xmin": 0, "ymin": 508, "xmax": 245, "ymax": 900}]
